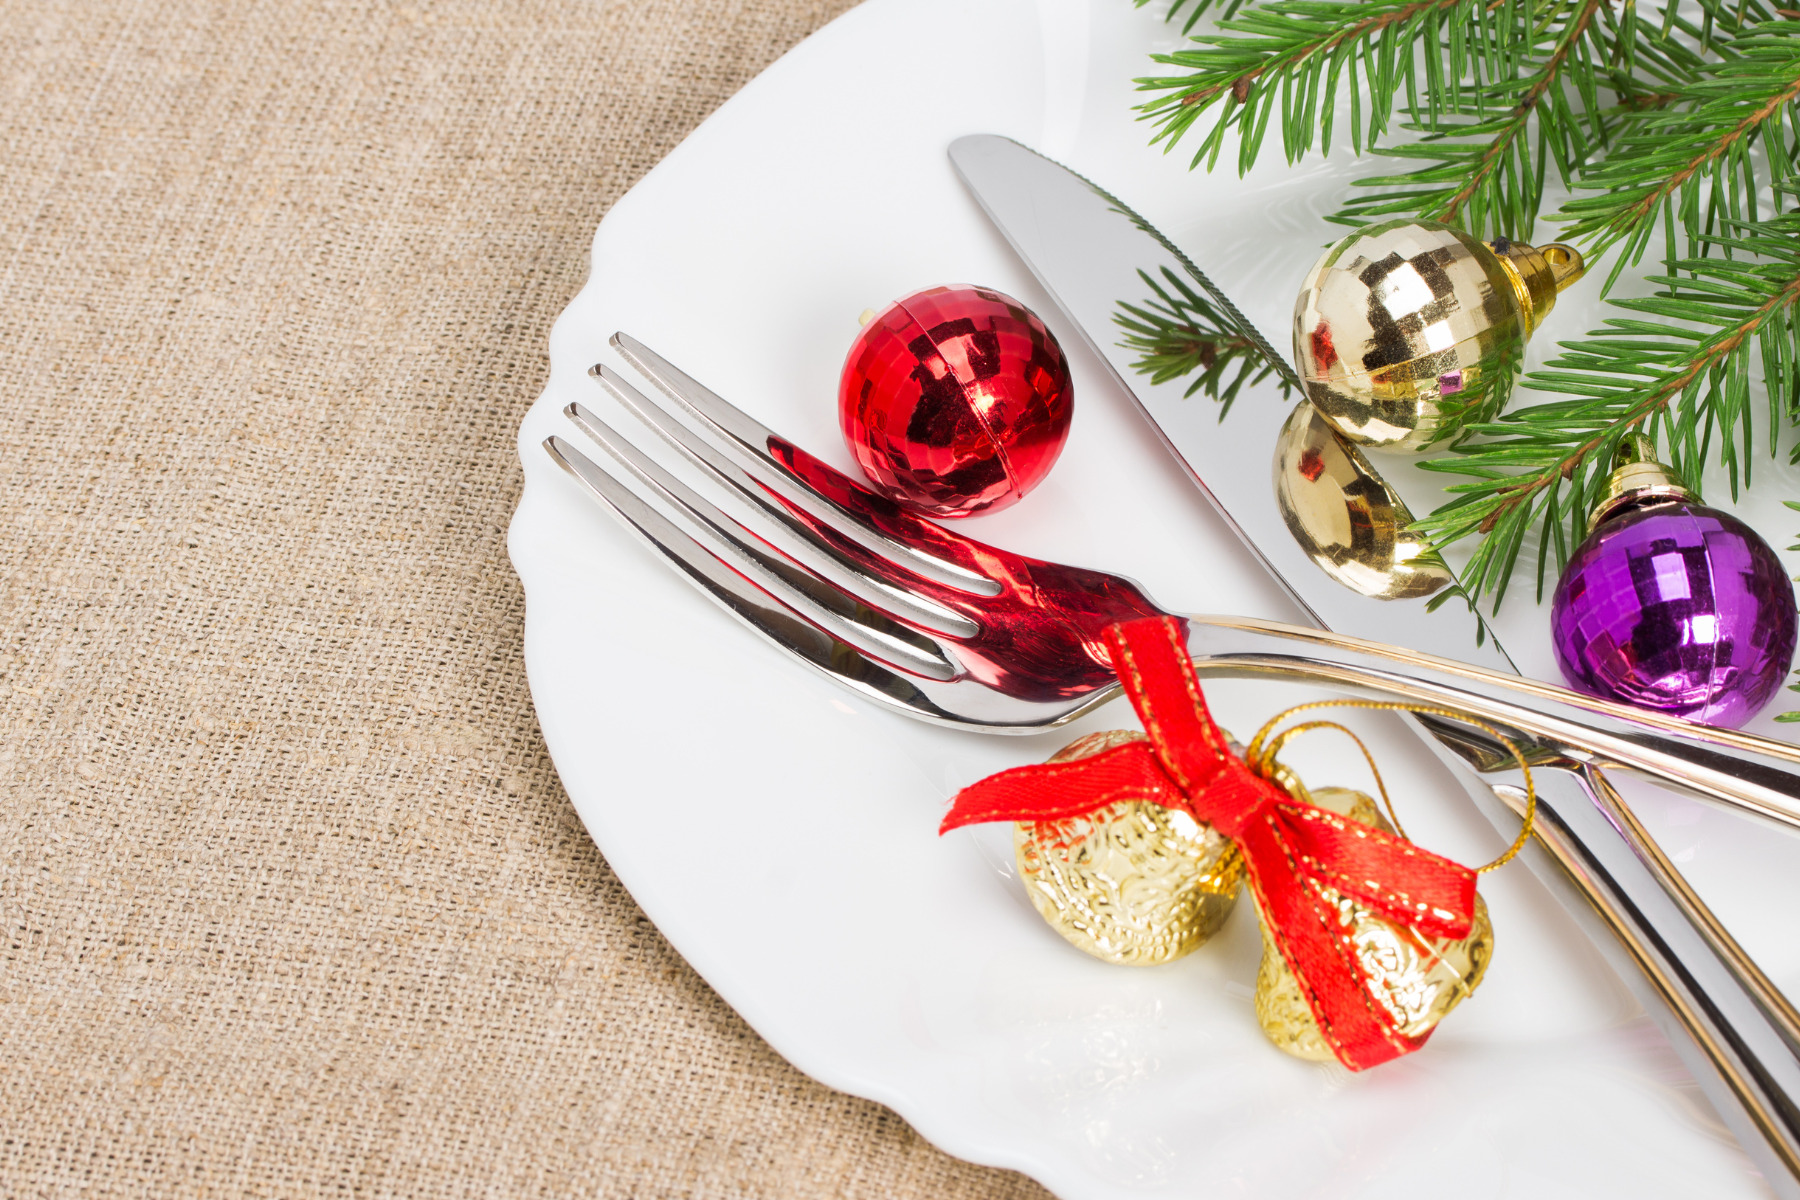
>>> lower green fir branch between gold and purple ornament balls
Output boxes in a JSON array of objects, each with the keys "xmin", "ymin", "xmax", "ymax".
[{"xmin": 1417, "ymin": 214, "xmax": 1800, "ymax": 606}]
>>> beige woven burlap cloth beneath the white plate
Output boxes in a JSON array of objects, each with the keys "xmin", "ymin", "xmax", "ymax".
[{"xmin": 0, "ymin": 0, "xmax": 1044, "ymax": 1198}]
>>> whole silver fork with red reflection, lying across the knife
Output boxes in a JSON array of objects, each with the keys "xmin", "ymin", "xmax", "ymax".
[{"xmin": 544, "ymin": 333, "xmax": 1800, "ymax": 828}]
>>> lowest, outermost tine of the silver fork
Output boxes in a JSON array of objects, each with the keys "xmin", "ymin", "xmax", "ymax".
[{"xmin": 544, "ymin": 437, "xmax": 967, "ymax": 725}]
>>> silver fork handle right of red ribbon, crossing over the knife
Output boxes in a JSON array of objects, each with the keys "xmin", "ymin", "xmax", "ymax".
[{"xmin": 1188, "ymin": 617, "xmax": 1800, "ymax": 829}]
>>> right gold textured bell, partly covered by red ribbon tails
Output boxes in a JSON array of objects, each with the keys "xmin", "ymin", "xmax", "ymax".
[{"xmin": 1256, "ymin": 775, "xmax": 1494, "ymax": 1063}]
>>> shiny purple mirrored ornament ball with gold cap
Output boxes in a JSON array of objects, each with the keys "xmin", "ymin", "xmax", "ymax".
[{"xmin": 1550, "ymin": 500, "xmax": 1796, "ymax": 727}]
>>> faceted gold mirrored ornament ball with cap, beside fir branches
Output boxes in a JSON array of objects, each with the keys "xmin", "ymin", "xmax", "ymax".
[{"xmin": 1294, "ymin": 219, "xmax": 1584, "ymax": 450}]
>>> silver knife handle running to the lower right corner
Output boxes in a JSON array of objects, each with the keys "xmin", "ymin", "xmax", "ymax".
[{"xmin": 1420, "ymin": 755, "xmax": 1800, "ymax": 1200}]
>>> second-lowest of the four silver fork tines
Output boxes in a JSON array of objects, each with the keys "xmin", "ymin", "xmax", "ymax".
[{"xmin": 549, "ymin": 414, "xmax": 961, "ymax": 680}]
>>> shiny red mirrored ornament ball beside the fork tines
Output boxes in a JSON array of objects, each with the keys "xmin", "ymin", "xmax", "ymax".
[{"xmin": 837, "ymin": 288, "xmax": 1075, "ymax": 516}]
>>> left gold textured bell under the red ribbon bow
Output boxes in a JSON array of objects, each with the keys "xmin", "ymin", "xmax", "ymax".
[{"xmin": 1013, "ymin": 729, "xmax": 1244, "ymax": 966}]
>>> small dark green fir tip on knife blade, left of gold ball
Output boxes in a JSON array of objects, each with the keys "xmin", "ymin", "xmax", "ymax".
[{"xmin": 1112, "ymin": 266, "xmax": 1292, "ymax": 413}]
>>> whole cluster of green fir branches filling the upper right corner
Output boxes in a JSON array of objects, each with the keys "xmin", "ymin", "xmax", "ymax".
[{"xmin": 1138, "ymin": 0, "xmax": 1800, "ymax": 604}]
